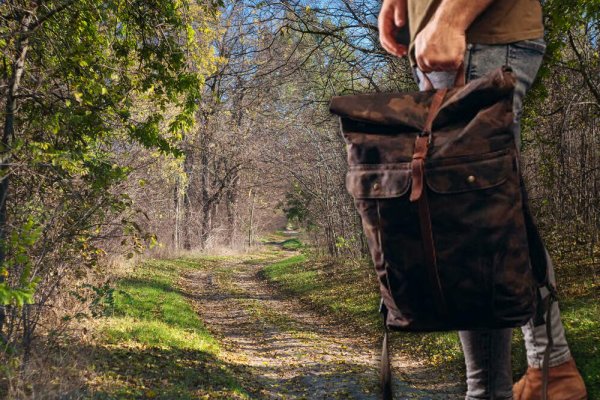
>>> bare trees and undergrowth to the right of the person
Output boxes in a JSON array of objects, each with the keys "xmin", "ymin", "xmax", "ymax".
[{"xmin": 524, "ymin": 0, "xmax": 600, "ymax": 264}]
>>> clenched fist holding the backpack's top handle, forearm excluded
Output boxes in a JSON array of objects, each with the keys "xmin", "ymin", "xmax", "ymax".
[{"xmin": 415, "ymin": 18, "xmax": 467, "ymax": 72}]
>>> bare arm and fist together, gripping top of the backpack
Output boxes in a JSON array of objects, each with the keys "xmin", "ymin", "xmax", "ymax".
[{"xmin": 415, "ymin": 0, "xmax": 494, "ymax": 72}]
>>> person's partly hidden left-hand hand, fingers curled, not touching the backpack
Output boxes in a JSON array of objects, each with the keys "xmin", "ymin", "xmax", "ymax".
[{"xmin": 378, "ymin": 0, "xmax": 407, "ymax": 57}]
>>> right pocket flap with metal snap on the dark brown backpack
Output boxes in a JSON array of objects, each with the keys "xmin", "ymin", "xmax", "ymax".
[{"xmin": 425, "ymin": 152, "xmax": 515, "ymax": 194}]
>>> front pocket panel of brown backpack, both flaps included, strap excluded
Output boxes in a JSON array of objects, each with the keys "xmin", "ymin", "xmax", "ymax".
[{"xmin": 346, "ymin": 150, "xmax": 533, "ymax": 330}]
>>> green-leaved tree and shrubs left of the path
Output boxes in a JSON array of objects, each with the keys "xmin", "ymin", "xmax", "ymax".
[{"xmin": 0, "ymin": 0, "xmax": 218, "ymax": 349}]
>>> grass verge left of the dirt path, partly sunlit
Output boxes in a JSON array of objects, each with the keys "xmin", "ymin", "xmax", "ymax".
[{"xmin": 89, "ymin": 259, "xmax": 248, "ymax": 399}]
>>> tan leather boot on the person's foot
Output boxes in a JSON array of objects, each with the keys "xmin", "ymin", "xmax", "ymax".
[{"xmin": 513, "ymin": 358, "xmax": 587, "ymax": 400}]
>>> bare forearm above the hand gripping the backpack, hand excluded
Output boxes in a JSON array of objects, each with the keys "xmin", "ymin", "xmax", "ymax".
[{"xmin": 431, "ymin": 0, "xmax": 494, "ymax": 31}]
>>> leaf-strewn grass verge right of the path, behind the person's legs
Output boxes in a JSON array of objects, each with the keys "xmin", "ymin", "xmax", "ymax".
[{"xmin": 264, "ymin": 250, "xmax": 600, "ymax": 399}]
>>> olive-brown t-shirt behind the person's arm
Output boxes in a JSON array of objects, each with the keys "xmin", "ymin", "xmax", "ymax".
[{"xmin": 408, "ymin": 0, "xmax": 544, "ymax": 63}]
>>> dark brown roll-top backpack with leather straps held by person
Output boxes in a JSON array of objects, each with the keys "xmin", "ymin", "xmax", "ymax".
[{"xmin": 330, "ymin": 67, "xmax": 555, "ymax": 398}]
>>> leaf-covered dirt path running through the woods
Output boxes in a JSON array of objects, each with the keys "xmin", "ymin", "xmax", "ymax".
[{"xmin": 180, "ymin": 261, "xmax": 462, "ymax": 400}]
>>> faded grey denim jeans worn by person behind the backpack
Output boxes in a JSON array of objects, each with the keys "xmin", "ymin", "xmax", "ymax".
[{"xmin": 415, "ymin": 39, "xmax": 571, "ymax": 400}]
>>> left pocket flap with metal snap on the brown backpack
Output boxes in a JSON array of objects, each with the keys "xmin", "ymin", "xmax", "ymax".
[{"xmin": 346, "ymin": 163, "xmax": 410, "ymax": 199}]
